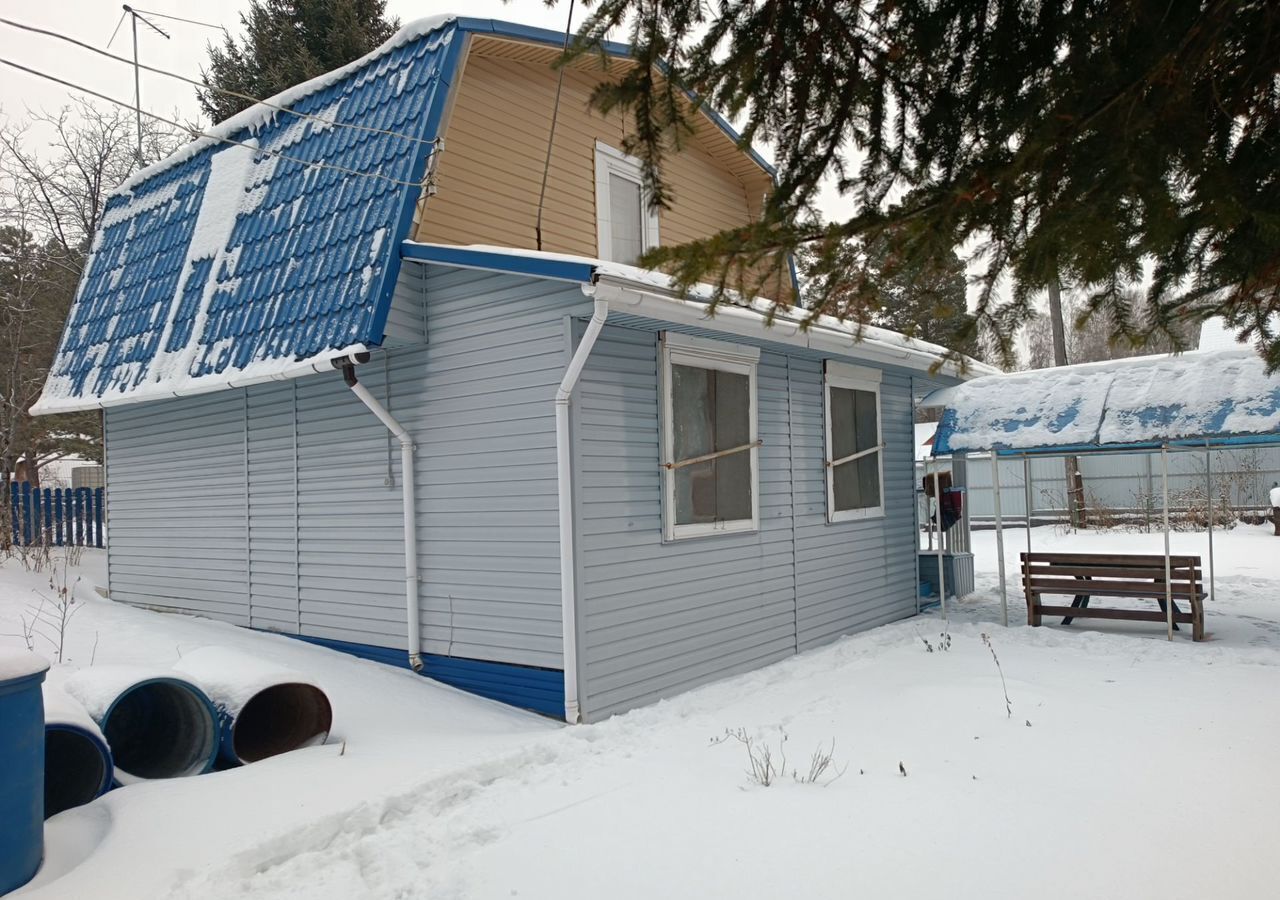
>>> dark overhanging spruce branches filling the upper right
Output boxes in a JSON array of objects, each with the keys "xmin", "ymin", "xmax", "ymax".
[{"xmin": 572, "ymin": 0, "xmax": 1280, "ymax": 369}]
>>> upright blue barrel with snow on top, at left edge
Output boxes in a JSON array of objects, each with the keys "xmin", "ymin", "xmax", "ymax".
[{"xmin": 0, "ymin": 650, "xmax": 49, "ymax": 894}]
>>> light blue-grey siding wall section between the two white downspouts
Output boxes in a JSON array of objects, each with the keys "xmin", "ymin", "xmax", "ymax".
[{"xmin": 403, "ymin": 269, "xmax": 585, "ymax": 668}]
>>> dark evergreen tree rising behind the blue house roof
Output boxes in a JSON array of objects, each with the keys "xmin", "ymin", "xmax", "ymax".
[{"xmin": 196, "ymin": 0, "xmax": 399, "ymax": 122}]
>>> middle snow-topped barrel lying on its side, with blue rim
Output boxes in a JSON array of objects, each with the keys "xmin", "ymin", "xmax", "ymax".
[{"xmin": 67, "ymin": 666, "xmax": 218, "ymax": 785}]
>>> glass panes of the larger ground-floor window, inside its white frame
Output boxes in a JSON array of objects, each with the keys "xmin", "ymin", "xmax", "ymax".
[{"xmin": 671, "ymin": 365, "xmax": 751, "ymax": 525}]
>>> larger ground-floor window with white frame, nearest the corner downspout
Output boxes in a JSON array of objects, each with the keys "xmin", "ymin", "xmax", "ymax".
[{"xmin": 662, "ymin": 334, "xmax": 760, "ymax": 540}]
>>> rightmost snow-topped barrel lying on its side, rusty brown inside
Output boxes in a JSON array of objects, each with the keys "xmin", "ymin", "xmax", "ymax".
[{"xmin": 174, "ymin": 647, "xmax": 333, "ymax": 766}]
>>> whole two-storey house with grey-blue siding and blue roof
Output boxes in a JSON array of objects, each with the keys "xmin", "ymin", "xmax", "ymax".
[{"xmin": 37, "ymin": 18, "xmax": 982, "ymax": 721}]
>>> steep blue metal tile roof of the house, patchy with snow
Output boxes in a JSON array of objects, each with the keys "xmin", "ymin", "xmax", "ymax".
[{"xmin": 33, "ymin": 17, "xmax": 772, "ymax": 412}]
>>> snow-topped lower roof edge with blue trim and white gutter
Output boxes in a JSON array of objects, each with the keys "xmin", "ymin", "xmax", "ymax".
[{"xmin": 401, "ymin": 241, "xmax": 1000, "ymax": 376}]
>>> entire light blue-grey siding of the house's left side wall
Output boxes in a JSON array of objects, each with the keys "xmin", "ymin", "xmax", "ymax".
[{"xmin": 108, "ymin": 264, "xmax": 584, "ymax": 668}]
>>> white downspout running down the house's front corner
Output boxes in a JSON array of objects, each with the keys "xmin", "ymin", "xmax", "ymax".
[{"xmin": 556, "ymin": 297, "xmax": 609, "ymax": 723}]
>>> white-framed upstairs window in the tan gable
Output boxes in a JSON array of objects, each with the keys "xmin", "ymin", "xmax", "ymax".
[{"xmin": 595, "ymin": 142, "xmax": 658, "ymax": 265}]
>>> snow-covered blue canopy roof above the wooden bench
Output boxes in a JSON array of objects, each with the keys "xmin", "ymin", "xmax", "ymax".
[{"xmin": 923, "ymin": 348, "xmax": 1280, "ymax": 456}]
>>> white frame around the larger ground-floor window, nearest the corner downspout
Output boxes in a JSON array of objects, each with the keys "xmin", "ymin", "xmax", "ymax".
[{"xmin": 658, "ymin": 332, "xmax": 760, "ymax": 542}]
